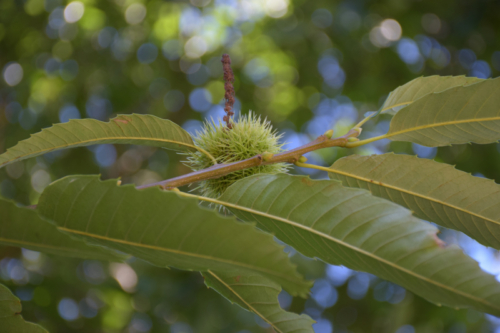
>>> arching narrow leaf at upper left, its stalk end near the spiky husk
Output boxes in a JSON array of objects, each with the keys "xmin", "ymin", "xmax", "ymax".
[{"xmin": 0, "ymin": 114, "xmax": 196, "ymax": 167}]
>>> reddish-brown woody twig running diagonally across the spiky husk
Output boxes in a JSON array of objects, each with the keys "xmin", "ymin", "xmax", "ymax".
[{"xmin": 137, "ymin": 129, "xmax": 360, "ymax": 189}]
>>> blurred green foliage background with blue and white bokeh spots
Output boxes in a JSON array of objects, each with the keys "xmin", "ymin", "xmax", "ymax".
[{"xmin": 0, "ymin": 0, "xmax": 500, "ymax": 333}]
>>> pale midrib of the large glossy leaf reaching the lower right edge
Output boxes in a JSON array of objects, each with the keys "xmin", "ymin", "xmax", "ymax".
[{"xmin": 181, "ymin": 192, "xmax": 500, "ymax": 310}]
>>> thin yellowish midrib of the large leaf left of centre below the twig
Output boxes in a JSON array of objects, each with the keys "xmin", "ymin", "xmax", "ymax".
[{"xmin": 57, "ymin": 226, "xmax": 297, "ymax": 283}]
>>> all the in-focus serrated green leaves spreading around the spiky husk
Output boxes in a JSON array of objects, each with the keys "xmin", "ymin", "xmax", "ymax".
[{"xmin": 0, "ymin": 77, "xmax": 500, "ymax": 332}]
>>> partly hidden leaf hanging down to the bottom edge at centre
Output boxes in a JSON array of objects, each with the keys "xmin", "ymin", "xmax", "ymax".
[{"xmin": 203, "ymin": 271, "xmax": 314, "ymax": 333}]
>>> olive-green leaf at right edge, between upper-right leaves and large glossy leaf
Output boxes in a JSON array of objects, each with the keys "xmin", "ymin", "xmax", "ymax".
[{"xmin": 329, "ymin": 154, "xmax": 500, "ymax": 249}]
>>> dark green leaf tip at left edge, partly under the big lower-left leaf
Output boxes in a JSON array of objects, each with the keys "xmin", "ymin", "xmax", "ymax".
[{"xmin": 0, "ymin": 198, "xmax": 125, "ymax": 261}]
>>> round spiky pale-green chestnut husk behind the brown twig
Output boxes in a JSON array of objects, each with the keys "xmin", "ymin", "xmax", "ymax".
[{"xmin": 185, "ymin": 112, "xmax": 288, "ymax": 198}]
